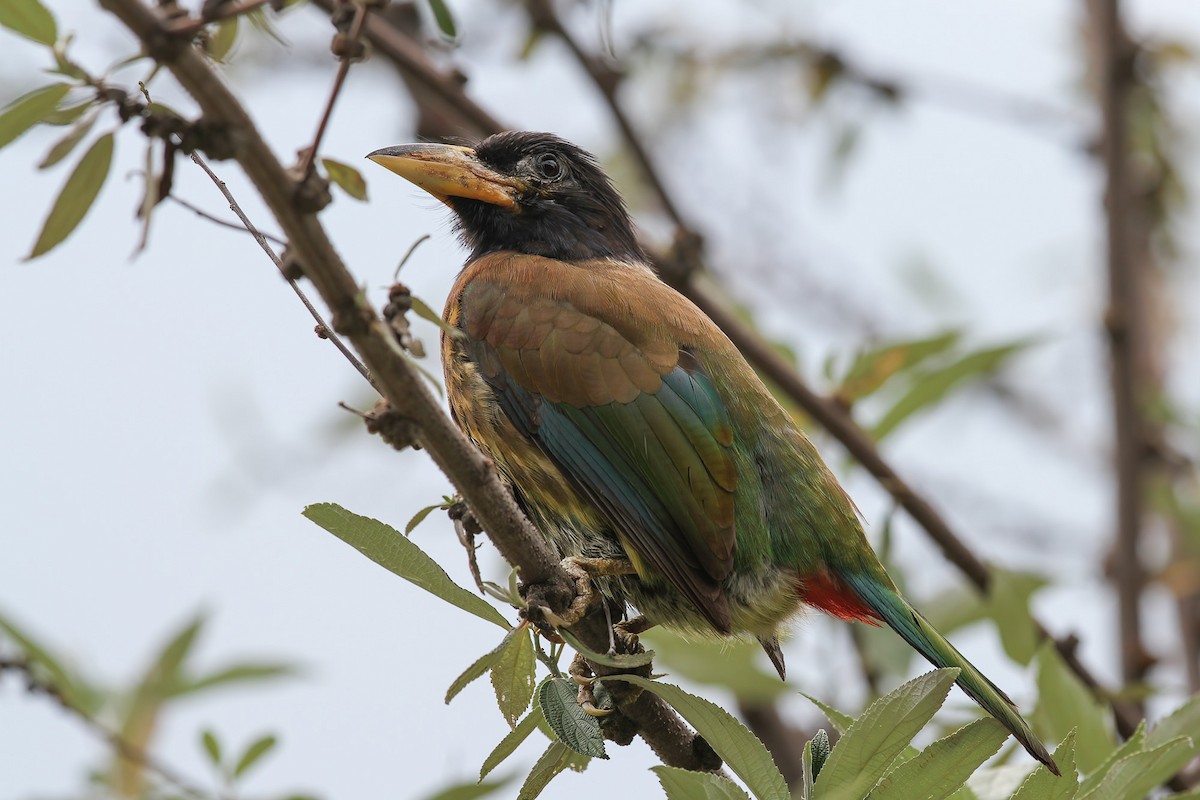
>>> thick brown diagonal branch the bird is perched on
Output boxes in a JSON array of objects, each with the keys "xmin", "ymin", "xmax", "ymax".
[{"xmin": 100, "ymin": 0, "xmax": 720, "ymax": 770}]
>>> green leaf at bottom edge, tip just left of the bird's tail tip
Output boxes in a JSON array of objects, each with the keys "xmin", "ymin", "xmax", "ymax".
[{"xmin": 871, "ymin": 717, "xmax": 1008, "ymax": 800}]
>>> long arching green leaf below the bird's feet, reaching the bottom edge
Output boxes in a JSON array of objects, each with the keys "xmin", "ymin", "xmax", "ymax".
[{"xmin": 604, "ymin": 675, "xmax": 791, "ymax": 800}]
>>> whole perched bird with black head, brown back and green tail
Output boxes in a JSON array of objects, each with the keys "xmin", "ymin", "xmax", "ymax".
[{"xmin": 367, "ymin": 131, "xmax": 1058, "ymax": 775}]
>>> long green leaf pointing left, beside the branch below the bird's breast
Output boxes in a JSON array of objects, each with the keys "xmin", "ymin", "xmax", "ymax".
[{"xmin": 304, "ymin": 503, "xmax": 510, "ymax": 630}]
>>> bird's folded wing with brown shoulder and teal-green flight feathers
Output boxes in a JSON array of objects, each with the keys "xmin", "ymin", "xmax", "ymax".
[{"xmin": 462, "ymin": 284, "xmax": 737, "ymax": 632}]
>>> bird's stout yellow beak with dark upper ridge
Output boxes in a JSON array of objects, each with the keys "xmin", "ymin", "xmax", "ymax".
[{"xmin": 367, "ymin": 144, "xmax": 527, "ymax": 210}]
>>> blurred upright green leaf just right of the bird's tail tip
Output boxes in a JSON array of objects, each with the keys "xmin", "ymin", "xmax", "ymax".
[{"xmin": 1033, "ymin": 642, "xmax": 1116, "ymax": 775}]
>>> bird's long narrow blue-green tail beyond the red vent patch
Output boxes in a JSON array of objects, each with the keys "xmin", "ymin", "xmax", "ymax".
[{"xmin": 841, "ymin": 575, "xmax": 1058, "ymax": 775}]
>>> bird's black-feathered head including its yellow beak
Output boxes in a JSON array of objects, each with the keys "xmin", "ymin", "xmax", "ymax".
[{"xmin": 367, "ymin": 131, "xmax": 643, "ymax": 260}]
